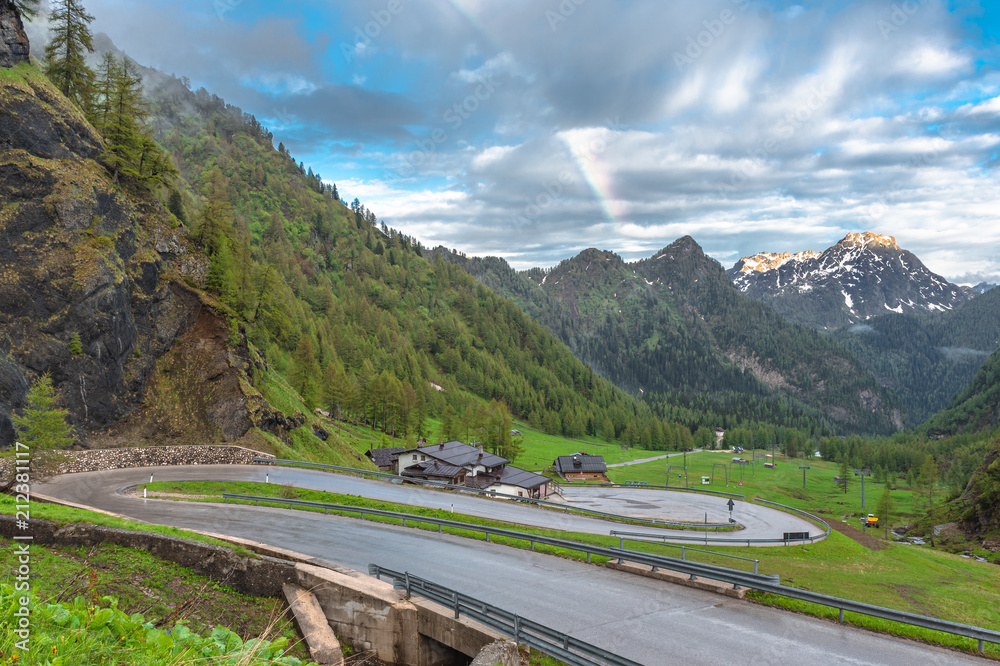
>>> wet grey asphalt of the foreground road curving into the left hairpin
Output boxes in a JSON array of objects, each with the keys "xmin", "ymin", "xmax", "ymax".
[{"xmin": 34, "ymin": 466, "xmax": 987, "ymax": 666}]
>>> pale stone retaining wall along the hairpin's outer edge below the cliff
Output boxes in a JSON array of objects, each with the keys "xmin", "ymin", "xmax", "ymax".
[{"xmin": 60, "ymin": 445, "xmax": 274, "ymax": 473}]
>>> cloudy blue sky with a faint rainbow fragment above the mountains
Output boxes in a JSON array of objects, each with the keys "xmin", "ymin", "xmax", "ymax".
[{"xmin": 41, "ymin": 0, "xmax": 1000, "ymax": 283}]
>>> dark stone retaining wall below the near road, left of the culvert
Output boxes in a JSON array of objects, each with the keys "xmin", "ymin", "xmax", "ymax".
[{"xmin": 0, "ymin": 515, "xmax": 296, "ymax": 597}]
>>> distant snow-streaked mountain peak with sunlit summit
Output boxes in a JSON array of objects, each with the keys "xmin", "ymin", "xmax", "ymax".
[{"xmin": 727, "ymin": 232, "xmax": 976, "ymax": 330}]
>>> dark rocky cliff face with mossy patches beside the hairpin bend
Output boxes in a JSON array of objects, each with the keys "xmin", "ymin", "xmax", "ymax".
[{"xmin": 0, "ymin": 65, "xmax": 262, "ymax": 445}]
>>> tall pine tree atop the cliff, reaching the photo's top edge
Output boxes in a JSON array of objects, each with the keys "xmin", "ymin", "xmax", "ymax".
[{"xmin": 45, "ymin": 0, "xmax": 94, "ymax": 114}]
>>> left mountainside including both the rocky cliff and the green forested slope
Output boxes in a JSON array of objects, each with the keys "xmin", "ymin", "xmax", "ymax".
[{"xmin": 0, "ymin": 53, "xmax": 672, "ymax": 452}]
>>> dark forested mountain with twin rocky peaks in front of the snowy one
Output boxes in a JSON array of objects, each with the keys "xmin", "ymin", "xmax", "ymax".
[{"xmin": 452, "ymin": 237, "xmax": 903, "ymax": 432}]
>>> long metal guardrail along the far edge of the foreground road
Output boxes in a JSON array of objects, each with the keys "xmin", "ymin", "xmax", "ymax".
[{"xmin": 223, "ymin": 493, "xmax": 1000, "ymax": 652}]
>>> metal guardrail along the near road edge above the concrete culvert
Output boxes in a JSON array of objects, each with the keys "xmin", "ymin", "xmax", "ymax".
[{"xmin": 368, "ymin": 564, "xmax": 642, "ymax": 666}]
